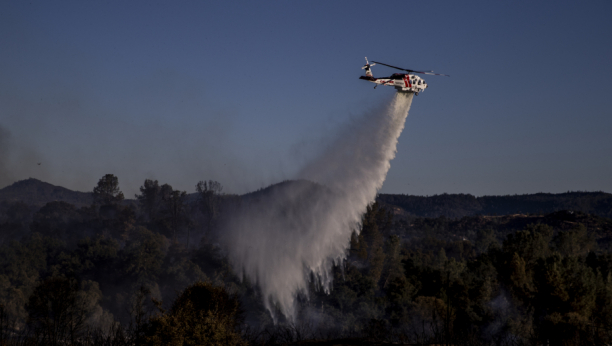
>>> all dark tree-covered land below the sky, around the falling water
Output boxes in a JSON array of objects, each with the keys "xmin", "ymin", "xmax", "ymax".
[{"xmin": 0, "ymin": 175, "xmax": 612, "ymax": 345}]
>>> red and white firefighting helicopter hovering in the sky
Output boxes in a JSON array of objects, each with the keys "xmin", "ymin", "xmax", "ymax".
[{"xmin": 359, "ymin": 57, "xmax": 450, "ymax": 95}]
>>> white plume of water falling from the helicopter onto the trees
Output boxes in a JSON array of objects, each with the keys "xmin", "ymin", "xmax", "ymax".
[{"xmin": 220, "ymin": 93, "xmax": 413, "ymax": 320}]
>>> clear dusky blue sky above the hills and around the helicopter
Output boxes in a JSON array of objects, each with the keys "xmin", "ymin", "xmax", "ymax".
[{"xmin": 0, "ymin": 1, "xmax": 612, "ymax": 198}]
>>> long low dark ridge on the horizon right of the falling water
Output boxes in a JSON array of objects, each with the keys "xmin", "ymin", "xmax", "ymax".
[{"xmin": 378, "ymin": 192, "xmax": 612, "ymax": 218}]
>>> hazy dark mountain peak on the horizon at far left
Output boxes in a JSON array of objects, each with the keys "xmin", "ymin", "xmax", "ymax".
[{"xmin": 0, "ymin": 178, "xmax": 93, "ymax": 207}]
